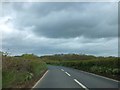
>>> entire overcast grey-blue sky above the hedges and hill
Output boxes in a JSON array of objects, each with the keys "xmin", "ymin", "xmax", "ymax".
[{"xmin": 0, "ymin": 2, "xmax": 118, "ymax": 56}]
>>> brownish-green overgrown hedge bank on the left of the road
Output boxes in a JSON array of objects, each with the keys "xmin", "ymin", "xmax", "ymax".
[{"xmin": 2, "ymin": 55, "xmax": 47, "ymax": 89}]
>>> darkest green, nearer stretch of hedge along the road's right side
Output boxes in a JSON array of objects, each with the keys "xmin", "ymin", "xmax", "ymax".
[{"xmin": 60, "ymin": 60, "xmax": 120, "ymax": 81}]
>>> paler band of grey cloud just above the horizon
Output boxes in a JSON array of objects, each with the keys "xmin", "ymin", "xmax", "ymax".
[{"xmin": 3, "ymin": 33, "xmax": 118, "ymax": 56}]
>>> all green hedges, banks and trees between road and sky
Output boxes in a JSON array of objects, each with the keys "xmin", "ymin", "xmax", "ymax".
[{"xmin": 2, "ymin": 53, "xmax": 120, "ymax": 88}]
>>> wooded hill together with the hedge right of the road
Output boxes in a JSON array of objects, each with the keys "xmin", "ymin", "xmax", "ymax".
[{"xmin": 41, "ymin": 54, "xmax": 120, "ymax": 80}]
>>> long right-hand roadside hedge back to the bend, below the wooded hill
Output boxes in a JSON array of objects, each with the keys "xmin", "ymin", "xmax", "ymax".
[{"xmin": 43, "ymin": 56, "xmax": 120, "ymax": 81}]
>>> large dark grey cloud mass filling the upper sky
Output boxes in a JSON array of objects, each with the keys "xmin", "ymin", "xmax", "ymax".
[{"xmin": 3, "ymin": 2, "xmax": 118, "ymax": 38}]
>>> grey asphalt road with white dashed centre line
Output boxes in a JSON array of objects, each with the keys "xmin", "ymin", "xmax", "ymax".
[{"xmin": 34, "ymin": 65, "xmax": 118, "ymax": 90}]
